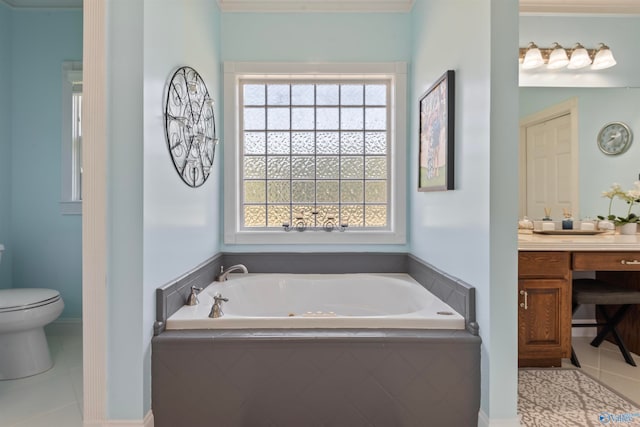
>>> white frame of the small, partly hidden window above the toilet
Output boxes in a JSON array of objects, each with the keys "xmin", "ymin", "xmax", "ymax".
[{"xmin": 60, "ymin": 61, "xmax": 82, "ymax": 215}]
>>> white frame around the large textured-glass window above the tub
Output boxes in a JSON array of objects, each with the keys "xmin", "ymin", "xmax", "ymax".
[{"xmin": 223, "ymin": 62, "xmax": 407, "ymax": 244}]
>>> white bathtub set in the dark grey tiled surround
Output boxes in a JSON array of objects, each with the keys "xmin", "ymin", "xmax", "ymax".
[{"xmin": 166, "ymin": 274, "xmax": 465, "ymax": 330}]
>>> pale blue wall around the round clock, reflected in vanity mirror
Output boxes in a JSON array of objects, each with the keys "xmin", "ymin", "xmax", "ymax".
[{"xmin": 520, "ymin": 87, "xmax": 640, "ymax": 218}]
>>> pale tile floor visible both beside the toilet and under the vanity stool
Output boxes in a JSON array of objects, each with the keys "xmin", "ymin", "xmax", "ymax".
[{"xmin": 0, "ymin": 332, "xmax": 640, "ymax": 427}]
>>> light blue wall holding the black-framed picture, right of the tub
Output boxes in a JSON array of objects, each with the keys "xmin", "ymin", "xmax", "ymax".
[{"xmin": 409, "ymin": 0, "xmax": 518, "ymax": 425}]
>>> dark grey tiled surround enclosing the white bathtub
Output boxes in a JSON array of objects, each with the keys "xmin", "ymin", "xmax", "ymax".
[{"xmin": 152, "ymin": 253, "xmax": 480, "ymax": 427}]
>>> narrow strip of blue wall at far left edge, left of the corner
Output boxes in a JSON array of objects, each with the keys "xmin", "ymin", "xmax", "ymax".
[{"xmin": 0, "ymin": 2, "xmax": 12, "ymax": 289}]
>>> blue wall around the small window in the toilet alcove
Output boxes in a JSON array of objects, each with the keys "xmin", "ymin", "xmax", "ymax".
[{"xmin": 10, "ymin": 9, "xmax": 82, "ymax": 318}]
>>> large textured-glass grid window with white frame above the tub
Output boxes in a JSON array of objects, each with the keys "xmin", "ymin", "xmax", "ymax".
[{"xmin": 225, "ymin": 63, "xmax": 406, "ymax": 243}]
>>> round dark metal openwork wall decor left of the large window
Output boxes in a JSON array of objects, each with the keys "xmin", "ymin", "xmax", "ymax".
[{"xmin": 164, "ymin": 67, "xmax": 218, "ymax": 187}]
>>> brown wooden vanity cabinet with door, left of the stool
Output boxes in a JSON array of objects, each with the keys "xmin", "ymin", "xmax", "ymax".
[{"xmin": 518, "ymin": 251, "xmax": 571, "ymax": 367}]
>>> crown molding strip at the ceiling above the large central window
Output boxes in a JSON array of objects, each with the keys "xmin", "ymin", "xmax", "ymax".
[{"xmin": 217, "ymin": 0, "xmax": 415, "ymax": 12}]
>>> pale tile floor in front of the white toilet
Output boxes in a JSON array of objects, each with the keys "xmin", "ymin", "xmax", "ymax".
[{"xmin": 0, "ymin": 332, "xmax": 82, "ymax": 427}]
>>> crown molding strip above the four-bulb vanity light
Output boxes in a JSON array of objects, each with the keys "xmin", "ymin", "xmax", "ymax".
[{"xmin": 520, "ymin": 0, "xmax": 640, "ymax": 15}]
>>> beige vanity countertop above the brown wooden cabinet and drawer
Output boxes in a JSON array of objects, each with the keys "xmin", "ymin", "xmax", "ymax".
[{"xmin": 518, "ymin": 230, "xmax": 640, "ymax": 251}]
